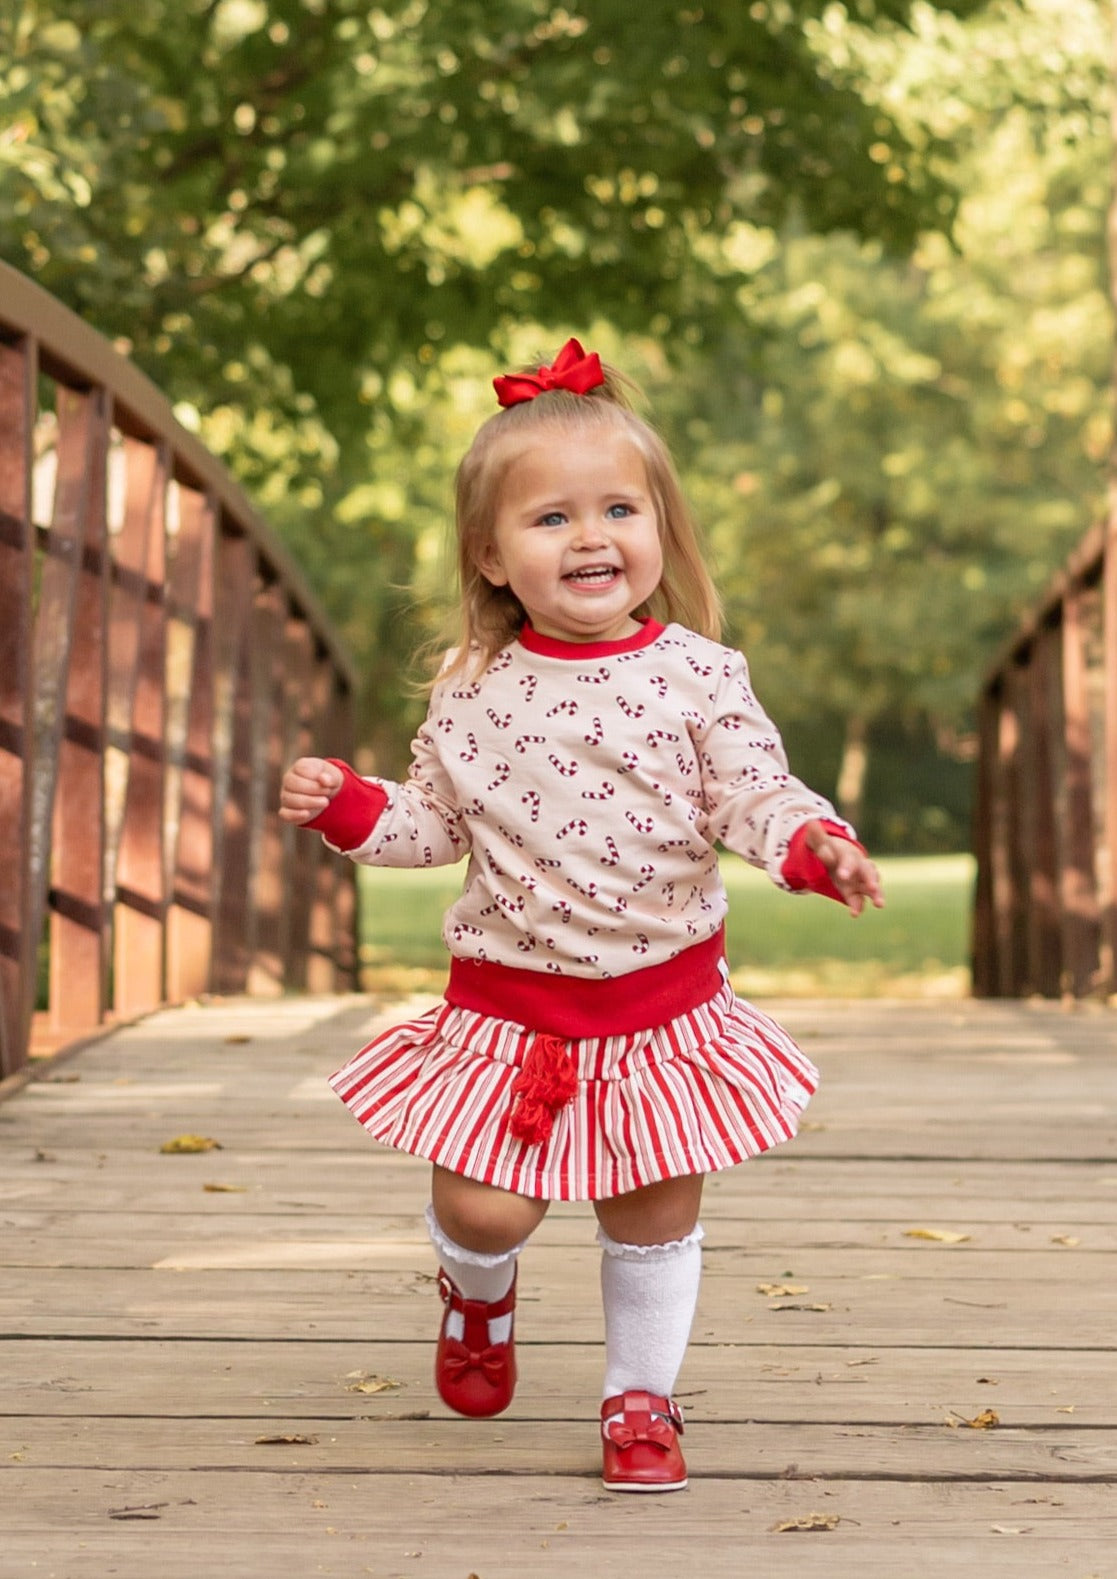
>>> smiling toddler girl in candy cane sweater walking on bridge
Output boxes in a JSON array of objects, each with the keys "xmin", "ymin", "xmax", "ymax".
[{"xmin": 281, "ymin": 339, "xmax": 883, "ymax": 1492}]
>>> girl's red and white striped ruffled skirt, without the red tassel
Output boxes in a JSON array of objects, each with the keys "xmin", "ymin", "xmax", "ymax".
[{"xmin": 330, "ymin": 985, "xmax": 818, "ymax": 1200}]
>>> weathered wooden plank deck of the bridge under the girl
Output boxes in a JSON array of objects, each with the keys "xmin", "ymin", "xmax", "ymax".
[{"xmin": 0, "ymin": 998, "xmax": 1117, "ymax": 1579}]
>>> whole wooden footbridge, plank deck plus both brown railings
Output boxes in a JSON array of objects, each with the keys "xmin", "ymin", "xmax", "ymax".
[{"xmin": 0, "ymin": 265, "xmax": 1117, "ymax": 1579}]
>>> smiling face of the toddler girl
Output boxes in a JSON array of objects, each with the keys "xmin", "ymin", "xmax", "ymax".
[{"xmin": 480, "ymin": 428, "xmax": 664, "ymax": 641}]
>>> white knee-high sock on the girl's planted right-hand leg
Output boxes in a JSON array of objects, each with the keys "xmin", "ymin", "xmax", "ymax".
[{"xmin": 597, "ymin": 1227, "xmax": 703, "ymax": 1397}]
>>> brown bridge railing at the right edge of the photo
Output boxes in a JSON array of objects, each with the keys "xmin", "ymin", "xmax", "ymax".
[{"xmin": 973, "ymin": 524, "xmax": 1117, "ymax": 998}]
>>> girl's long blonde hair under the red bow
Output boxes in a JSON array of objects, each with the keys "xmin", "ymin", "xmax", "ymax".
[{"xmin": 438, "ymin": 355, "xmax": 722, "ymax": 677}]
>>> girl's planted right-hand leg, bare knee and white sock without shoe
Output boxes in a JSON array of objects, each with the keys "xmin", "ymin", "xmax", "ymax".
[{"xmin": 594, "ymin": 1175, "xmax": 703, "ymax": 1397}]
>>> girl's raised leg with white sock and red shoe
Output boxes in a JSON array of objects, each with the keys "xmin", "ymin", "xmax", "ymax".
[{"xmin": 427, "ymin": 1167, "xmax": 547, "ymax": 1416}]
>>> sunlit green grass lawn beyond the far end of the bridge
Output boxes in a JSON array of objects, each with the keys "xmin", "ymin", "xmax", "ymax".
[{"xmin": 359, "ymin": 856, "xmax": 973, "ymax": 998}]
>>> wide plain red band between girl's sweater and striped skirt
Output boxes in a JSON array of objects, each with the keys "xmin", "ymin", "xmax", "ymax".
[{"xmin": 444, "ymin": 927, "xmax": 725, "ymax": 1041}]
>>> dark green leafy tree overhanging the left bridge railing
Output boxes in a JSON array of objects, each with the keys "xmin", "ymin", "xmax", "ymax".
[{"xmin": 0, "ymin": 0, "xmax": 965, "ymax": 761}]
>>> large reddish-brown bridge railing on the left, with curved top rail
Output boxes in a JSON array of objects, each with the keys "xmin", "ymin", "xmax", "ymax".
[{"xmin": 0, "ymin": 265, "xmax": 355, "ymax": 1077}]
